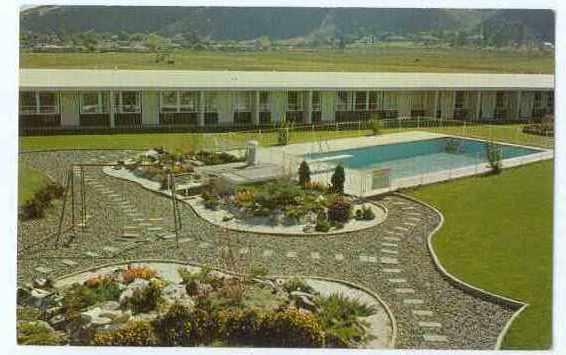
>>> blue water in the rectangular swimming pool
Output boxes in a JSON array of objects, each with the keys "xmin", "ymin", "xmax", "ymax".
[{"xmin": 304, "ymin": 137, "xmax": 540, "ymax": 179}]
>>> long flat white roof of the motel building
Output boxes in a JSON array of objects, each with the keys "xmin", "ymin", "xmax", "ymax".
[{"xmin": 20, "ymin": 69, "xmax": 554, "ymax": 91}]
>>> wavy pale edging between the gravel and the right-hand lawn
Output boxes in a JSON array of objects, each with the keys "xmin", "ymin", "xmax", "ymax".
[{"xmin": 394, "ymin": 192, "xmax": 529, "ymax": 350}]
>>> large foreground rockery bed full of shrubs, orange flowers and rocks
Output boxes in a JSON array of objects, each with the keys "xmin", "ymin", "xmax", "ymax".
[{"xmin": 18, "ymin": 264, "xmax": 385, "ymax": 347}]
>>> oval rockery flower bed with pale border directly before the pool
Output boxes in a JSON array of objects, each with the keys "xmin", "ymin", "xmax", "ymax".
[{"xmin": 192, "ymin": 180, "xmax": 384, "ymax": 234}]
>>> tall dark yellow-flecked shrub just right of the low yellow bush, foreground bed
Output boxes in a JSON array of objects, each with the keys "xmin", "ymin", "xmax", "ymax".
[{"xmin": 153, "ymin": 303, "xmax": 193, "ymax": 346}]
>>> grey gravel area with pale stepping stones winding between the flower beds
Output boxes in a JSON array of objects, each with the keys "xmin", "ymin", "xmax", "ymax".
[{"xmin": 18, "ymin": 151, "xmax": 524, "ymax": 349}]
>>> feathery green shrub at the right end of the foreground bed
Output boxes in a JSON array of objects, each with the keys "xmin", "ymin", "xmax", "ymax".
[{"xmin": 317, "ymin": 294, "xmax": 376, "ymax": 347}]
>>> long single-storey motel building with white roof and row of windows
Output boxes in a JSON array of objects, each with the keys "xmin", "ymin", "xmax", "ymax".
[{"xmin": 19, "ymin": 69, "xmax": 554, "ymax": 132}]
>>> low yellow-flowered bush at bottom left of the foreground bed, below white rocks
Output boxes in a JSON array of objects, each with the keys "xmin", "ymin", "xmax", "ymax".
[{"xmin": 94, "ymin": 321, "xmax": 158, "ymax": 346}]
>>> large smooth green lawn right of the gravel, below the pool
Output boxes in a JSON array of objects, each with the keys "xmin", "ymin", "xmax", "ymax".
[{"xmin": 409, "ymin": 161, "xmax": 553, "ymax": 350}]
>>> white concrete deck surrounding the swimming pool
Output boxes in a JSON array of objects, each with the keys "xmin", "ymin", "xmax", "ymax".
[{"xmin": 257, "ymin": 131, "xmax": 554, "ymax": 197}]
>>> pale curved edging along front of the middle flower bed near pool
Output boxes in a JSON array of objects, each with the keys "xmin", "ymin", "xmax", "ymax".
[{"xmin": 102, "ymin": 167, "xmax": 389, "ymax": 237}]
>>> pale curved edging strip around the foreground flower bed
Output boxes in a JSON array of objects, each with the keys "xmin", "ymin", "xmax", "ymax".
[{"xmin": 54, "ymin": 259, "xmax": 398, "ymax": 350}]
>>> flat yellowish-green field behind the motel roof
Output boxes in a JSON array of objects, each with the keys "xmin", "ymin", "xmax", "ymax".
[{"xmin": 20, "ymin": 48, "xmax": 554, "ymax": 73}]
